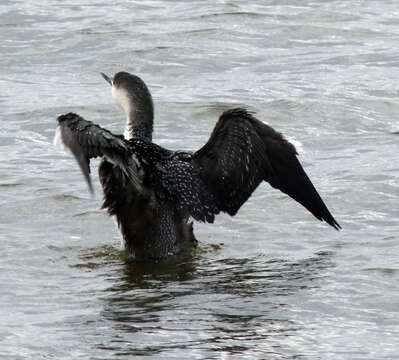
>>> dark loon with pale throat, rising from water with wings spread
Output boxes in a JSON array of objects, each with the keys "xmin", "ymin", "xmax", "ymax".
[{"xmin": 56, "ymin": 71, "xmax": 341, "ymax": 261}]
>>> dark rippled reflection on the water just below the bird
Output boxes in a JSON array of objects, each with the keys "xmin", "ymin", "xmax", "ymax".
[{"xmin": 83, "ymin": 248, "xmax": 333, "ymax": 356}]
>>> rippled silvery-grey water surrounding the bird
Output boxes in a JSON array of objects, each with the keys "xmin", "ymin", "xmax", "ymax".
[{"xmin": 0, "ymin": 0, "xmax": 399, "ymax": 359}]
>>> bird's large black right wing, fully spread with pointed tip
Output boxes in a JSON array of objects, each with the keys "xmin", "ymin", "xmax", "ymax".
[{"xmin": 192, "ymin": 108, "xmax": 340, "ymax": 230}]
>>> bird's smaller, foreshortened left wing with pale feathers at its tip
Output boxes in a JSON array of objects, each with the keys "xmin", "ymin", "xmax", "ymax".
[{"xmin": 56, "ymin": 113, "xmax": 141, "ymax": 192}]
